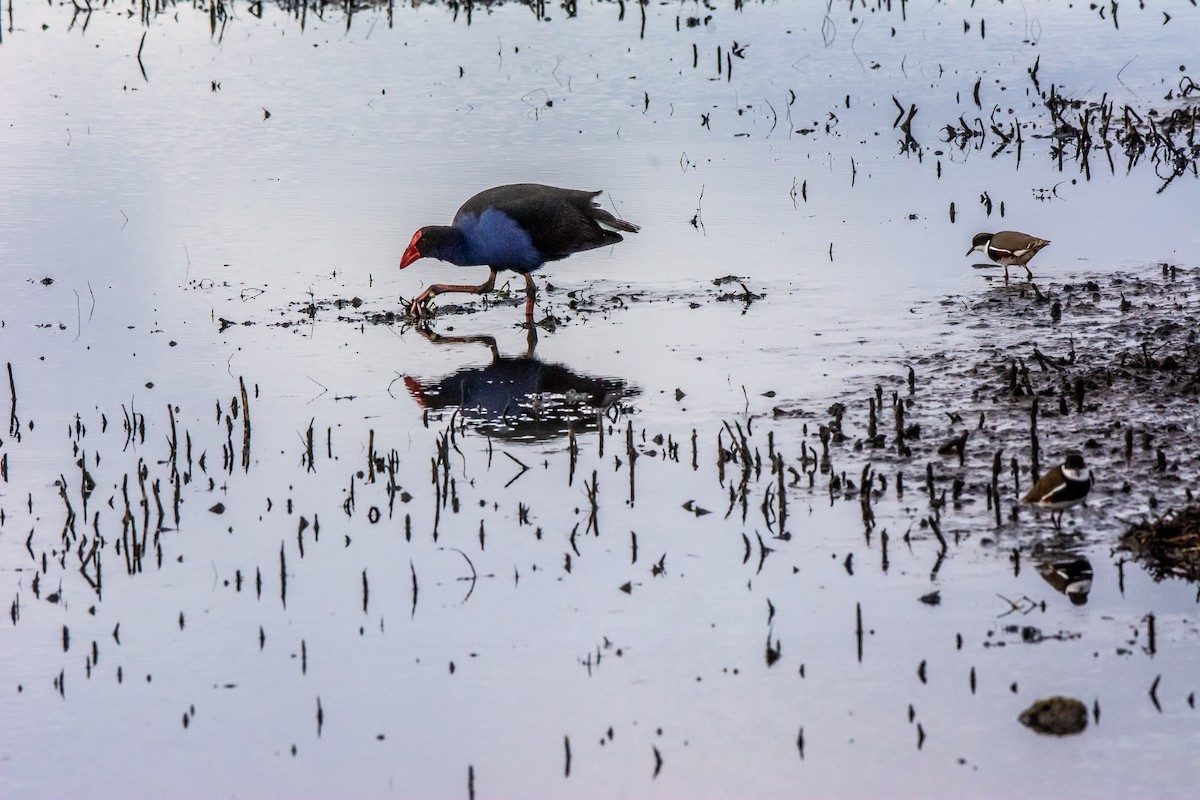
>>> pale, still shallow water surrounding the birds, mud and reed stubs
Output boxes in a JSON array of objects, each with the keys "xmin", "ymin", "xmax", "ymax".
[{"xmin": 0, "ymin": 2, "xmax": 1200, "ymax": 798}]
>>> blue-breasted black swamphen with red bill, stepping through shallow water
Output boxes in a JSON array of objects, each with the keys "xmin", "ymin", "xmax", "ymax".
[{"xmin": 400, "ymin": 184, "xmax": 637, "ymax": 317}]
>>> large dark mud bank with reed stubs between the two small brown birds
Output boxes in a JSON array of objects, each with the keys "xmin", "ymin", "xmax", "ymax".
[{"xmin": 796, "ymin": 265, "xmax": 1200, "ymax": 541}]
